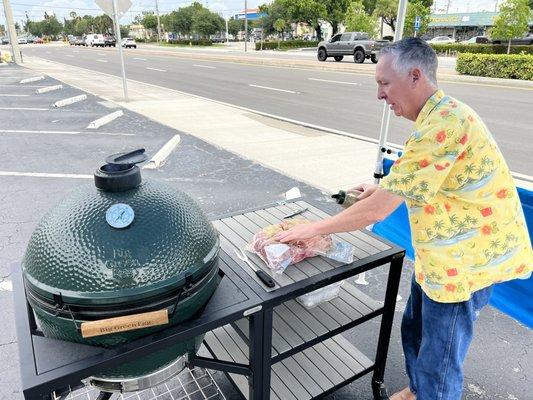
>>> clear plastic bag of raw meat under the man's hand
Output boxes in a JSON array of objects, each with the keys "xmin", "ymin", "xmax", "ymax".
[{"xmin": 246, "ymin": 219, "xmax": 354, "ymax": 273}]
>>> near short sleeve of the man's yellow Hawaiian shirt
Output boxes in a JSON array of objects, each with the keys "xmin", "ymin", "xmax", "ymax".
[{"xmin": 380, "ymin": 125, "xmax": 467, "ymax": 204}]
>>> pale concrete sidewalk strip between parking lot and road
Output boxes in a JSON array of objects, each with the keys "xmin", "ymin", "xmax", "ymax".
[{"xmin": 20, "ymin": 57, "xmax": 533, "ymax": 193}]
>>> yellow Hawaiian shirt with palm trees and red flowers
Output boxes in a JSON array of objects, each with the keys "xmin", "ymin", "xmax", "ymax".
[{"xmin": 380, "ymin": 90, "xmax": 533, "ymax": 303}]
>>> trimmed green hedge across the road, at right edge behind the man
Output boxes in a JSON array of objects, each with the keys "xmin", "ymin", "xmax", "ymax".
[{"xmin": 455, "ymin": 53, "xmax": 533, "ymax": 81}]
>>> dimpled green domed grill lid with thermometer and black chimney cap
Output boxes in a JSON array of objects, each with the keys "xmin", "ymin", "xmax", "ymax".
[{"xmin": 22, "ymin": 149, "xmax": 219, "ymax": 305}]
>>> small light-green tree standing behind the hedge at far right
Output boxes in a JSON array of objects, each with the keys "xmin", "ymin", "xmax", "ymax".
[{"xmin": 491, "ymin": 0, "xmax": 530, "ymax": 54}]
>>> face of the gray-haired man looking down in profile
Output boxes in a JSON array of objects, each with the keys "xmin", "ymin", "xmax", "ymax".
[{"xmin": 376, "ymin": 54, "xmax": 416, "ymax": 121}]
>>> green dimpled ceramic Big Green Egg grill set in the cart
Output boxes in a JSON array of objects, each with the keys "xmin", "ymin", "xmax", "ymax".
[{"xmin": 22, "ymin": 149, "xmax": 220, "ymax": 392}]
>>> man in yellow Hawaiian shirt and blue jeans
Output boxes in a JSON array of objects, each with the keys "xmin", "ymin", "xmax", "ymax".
[{"xmin": 276, "ymin": 38, "xmax": 533, "ymax": 400}]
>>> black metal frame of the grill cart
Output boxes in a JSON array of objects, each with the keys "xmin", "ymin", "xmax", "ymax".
[{"xmin": 13, "ymin": 202, "xmax": 404, "ymax": 400}]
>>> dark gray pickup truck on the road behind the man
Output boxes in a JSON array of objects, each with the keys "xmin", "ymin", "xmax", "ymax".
[{"xmin": 317, "ymin": 32, "xmax": 388, "ymax": 63}]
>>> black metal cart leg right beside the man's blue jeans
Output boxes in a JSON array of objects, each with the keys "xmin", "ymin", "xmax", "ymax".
[{"xmin": 372, "ymin": 254, "xmax": 403, "ymax": 400}]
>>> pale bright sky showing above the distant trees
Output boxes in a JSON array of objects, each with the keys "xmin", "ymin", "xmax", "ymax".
[{"xmin": 0, "ymin": 0, "xmax": 503, "ymax": 24}]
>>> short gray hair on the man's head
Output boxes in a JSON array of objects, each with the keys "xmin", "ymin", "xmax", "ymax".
[{"xmin": 380, "ymin": 38, "xmax": 438, "ymax": 85}]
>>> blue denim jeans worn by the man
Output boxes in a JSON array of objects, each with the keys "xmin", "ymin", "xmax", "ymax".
[{"xmin": 402, "ymin": 275, "xmax": 492, "ymax": 400}]
